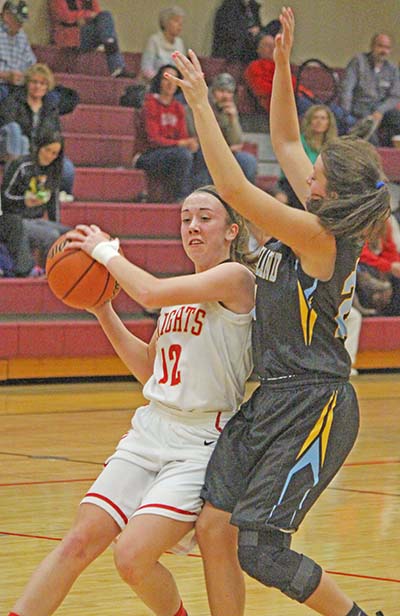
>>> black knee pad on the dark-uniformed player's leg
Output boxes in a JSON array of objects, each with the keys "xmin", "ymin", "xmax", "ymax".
[{"xmin": 238, "ymin": 529, "xmax": 322, "ymax": 603}]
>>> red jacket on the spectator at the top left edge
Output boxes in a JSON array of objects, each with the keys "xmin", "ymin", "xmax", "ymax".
[{"xmin": 49, "ymin": 0, "xmax": 101, "ymax": 47}]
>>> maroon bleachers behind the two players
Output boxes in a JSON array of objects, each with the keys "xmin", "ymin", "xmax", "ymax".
[{"xmin": 0, "ymin": 47, "xmax": 400, "ymax": 381}]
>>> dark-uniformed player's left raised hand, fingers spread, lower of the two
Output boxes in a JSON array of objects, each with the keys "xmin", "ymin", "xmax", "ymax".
[{"xmin": 165, "ymin": 49, "xmax": 208, "ymax": 109}]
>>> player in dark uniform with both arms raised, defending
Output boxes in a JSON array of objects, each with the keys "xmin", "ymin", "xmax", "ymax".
[{"xmin": 171, "ymin": 9, "xmax": 389, "ymax": 616}]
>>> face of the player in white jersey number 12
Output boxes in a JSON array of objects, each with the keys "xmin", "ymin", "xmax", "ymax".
[{"xmin": 181, "ymin": 192, "xmax": 238, "ymax": 271}]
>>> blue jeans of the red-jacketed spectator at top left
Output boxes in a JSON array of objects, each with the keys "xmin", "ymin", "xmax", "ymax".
[{"xmin": 79, "ymin": 11, "xmax": 125, "ymax": 73}]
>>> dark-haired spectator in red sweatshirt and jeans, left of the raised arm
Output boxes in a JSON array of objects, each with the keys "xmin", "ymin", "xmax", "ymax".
[{"xmin": 136, "ymin": 64, "xmax": 199, "ymax": 201}]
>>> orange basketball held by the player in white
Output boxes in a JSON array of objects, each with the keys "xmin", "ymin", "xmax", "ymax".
[{"xmin": 46, "ymin": 234, "xmax": 120, "ymax": 309}]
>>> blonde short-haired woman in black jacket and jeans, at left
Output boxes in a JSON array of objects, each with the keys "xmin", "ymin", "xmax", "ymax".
[{"xmin": 0, "ymin": 64, "xmax": 75, "ymax": 195}]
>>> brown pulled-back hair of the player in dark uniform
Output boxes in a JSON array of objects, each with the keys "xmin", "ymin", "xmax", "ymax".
[{"xmin": 307, "ymin": 137, "xmax": 390, "ymax": 242}]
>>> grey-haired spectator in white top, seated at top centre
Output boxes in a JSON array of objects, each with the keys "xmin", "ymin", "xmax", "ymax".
[{"xmin": 140, "ymin": 6, "xmax": 186, "ymax": 83}]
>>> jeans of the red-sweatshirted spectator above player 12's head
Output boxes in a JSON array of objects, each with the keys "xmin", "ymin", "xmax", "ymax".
[{"xmin": 136, "ymin": 145, "xmax": 193, "ymax": 201}]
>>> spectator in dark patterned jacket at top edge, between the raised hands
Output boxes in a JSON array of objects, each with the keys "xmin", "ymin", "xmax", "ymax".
[{"xmin": 211, "ymin": 0, "xmax": 262, "ymax": 64}]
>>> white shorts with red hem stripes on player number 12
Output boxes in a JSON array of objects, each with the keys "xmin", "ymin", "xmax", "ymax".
[{"xmin": 81, "ymin": 404, "xmax": 230, "ymax": 552}]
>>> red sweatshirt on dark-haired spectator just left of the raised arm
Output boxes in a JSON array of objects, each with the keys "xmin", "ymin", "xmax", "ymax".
[{"xmin": 142, "ymin": 94, "xmax": 188, "ymax": 149}]
